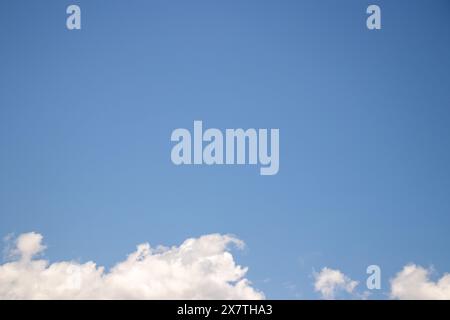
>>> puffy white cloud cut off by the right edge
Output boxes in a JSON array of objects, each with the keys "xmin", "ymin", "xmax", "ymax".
[{"xmin": 390, "ymin": 264, "xmax": 450, "ymax": 300}]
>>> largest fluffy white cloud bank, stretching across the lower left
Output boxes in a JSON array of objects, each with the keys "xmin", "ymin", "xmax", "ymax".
[{"xmin": 0, "ymin": 232, "xmax": 264, "ymax": 299}]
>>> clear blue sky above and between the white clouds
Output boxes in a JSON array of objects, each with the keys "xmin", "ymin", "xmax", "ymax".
[{"xmin": 0, "ymin": 0, "xmax": 450, "ymax": 299}]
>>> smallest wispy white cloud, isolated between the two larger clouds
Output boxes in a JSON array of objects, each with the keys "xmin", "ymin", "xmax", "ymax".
[{"xmin": 314, "ymin": 268, "xmax": 358, "ymax": 299}]
